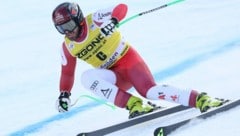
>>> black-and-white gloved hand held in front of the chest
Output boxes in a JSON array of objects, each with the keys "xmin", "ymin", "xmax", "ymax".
[{"xmin": 101, "ymin": 18, "xmax": 118, "ymax": 36}]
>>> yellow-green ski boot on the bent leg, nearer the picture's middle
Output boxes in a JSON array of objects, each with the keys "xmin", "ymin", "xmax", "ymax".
[{"xmin": 126, "ymin": 96, "xmax": 155, "ymax": 119}]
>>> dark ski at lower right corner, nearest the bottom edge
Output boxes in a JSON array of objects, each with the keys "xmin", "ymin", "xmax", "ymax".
[{"xmin": 154, "ymin": 99, "xmax": 240, "ymax": 136}]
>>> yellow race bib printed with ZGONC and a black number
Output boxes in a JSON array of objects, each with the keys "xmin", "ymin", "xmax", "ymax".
[{"xmin": 65, "ymin": 14, "xmax": 129, "ymax": 68}]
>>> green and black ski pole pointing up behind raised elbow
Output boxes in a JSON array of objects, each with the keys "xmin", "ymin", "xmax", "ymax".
[{"xmin": 117, "ymin": 0, "xmax": 184, "ymax": 27}]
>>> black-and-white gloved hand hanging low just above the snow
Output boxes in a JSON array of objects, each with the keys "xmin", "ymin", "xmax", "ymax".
[{"xmin": 56, "ymin": 92, "xmax": 71, "ymax": 112}]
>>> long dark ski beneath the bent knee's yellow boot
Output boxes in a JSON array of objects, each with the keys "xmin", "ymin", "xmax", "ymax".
[{"xmin": 77, "ymin": 105, "xmax": 190, "ymax": 136}]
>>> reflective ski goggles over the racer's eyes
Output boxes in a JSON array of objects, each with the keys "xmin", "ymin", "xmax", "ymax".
[{"xmin": 55, "ymin": 19, "xmax": 77, "ymax": 34}]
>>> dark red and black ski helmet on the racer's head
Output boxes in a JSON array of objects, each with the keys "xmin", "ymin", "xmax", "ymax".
[{"xmin": 52, "ymin": 2, "xmax": 84, "ymax": 34}]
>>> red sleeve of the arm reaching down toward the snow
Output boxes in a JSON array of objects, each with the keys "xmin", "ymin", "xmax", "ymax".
[{"xmin": 60, "ymin": 43, "xmax": 76, "ymax": 92}]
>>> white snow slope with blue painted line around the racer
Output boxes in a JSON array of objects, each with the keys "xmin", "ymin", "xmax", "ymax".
[{"xmin": 0, "ymin": 0, "xmax": 240, "ymax": 136}]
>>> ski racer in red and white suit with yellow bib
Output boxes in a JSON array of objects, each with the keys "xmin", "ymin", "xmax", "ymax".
[{"xmin": 52, "ymin": 2, "xmax": 223, "ymax": 118}]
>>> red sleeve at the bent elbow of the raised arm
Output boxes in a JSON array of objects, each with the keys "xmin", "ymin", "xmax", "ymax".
[{"xmin": 112, "ymin": 4, "xmax": 128, "ymax": 22}]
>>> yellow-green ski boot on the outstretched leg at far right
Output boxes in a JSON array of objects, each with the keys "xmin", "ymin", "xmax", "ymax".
[{"xmin": 196, "ymin": 93, "xmax": 227, "ymax": 113}]
